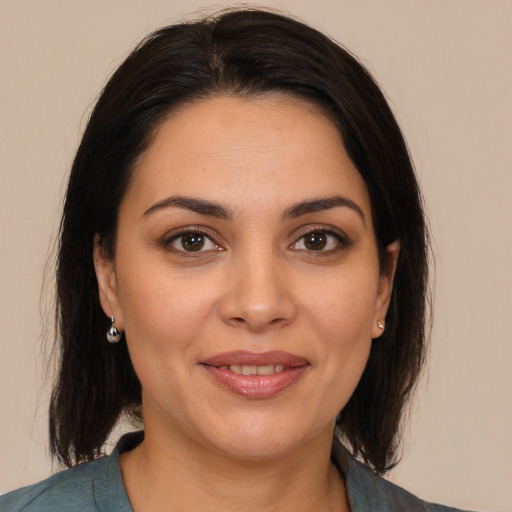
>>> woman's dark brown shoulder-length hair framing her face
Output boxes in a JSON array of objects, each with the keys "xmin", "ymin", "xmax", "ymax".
[{"xmin": 50, "ymin": 9, "xmax": 428, "ymax": 473}]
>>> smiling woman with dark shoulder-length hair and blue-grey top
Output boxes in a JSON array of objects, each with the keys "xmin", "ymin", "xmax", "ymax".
[{"xmin": 0, "ymin": 10, "xmax": 474, "ymax": 512}]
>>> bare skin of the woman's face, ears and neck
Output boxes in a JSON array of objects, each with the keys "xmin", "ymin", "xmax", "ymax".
[{"xmin": 94, "ymin": 95, "xmax": 399, "ymax": 511}]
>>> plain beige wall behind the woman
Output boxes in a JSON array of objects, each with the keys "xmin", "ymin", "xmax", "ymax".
[{"xmin": 0, "ymin": 0, "xmax": 512, "ymax": 511}]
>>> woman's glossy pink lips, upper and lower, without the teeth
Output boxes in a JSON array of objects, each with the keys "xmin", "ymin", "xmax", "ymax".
[{"xmin": 201, "ymin": 351, "xmax": 310, "ymax": 398}]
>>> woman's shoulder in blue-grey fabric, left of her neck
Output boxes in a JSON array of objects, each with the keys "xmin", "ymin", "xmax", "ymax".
[{"xmin": 0, "ymin": 442, "xmax": 132, "ymax": 512}]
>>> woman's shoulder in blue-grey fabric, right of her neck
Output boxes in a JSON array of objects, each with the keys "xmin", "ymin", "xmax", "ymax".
[{"xmin": 333, "ymin": 439, "xmax": 476, "ymax": 512}]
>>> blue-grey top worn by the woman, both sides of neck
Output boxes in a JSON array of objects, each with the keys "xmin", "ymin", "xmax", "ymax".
[{"xmin": 0, "ymin": 432, "xmax": 472, "ymax": 512}]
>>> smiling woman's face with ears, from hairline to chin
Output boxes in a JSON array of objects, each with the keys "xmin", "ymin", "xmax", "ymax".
[{"xmin": 95, "ymin": 95, "xmax": 398, "ymax": 458}]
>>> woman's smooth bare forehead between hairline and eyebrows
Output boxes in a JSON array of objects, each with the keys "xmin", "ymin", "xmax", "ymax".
[{"xmin": 125, "ymin": 95, "xmax": 369, "ymax": 218}]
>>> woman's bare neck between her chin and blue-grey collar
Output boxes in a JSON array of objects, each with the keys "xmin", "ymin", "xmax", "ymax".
[{"xmin": 121, "ymin": 429, "xmax": 349, "ymax": 512}]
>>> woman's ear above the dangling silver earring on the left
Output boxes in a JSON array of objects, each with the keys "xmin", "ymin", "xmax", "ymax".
[{"xmin": 93, "ymin": 233, "xmax": 124, "ymax": 331}]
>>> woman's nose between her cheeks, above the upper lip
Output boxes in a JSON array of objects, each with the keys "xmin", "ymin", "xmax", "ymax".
[{"xmin": 220, "ymin": 251, "xmax": 296, "ymax": 332}]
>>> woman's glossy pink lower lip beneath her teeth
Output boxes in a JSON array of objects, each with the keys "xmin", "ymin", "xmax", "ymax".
[{"xmin": 203, "ymin": 365, "xmax": 309, "ymax": 398}]
